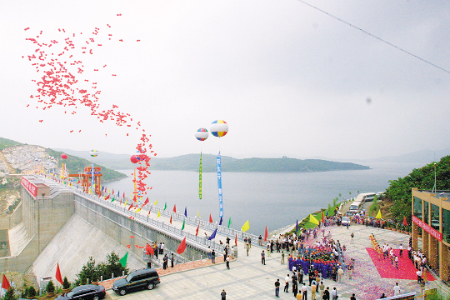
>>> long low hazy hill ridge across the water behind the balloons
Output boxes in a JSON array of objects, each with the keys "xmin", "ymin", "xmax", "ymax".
[{"xmin": 60, "ymin": 149, "xmax": 370, "ymax": 172}]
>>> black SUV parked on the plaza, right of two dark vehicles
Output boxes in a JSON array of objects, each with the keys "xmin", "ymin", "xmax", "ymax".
[{"xmin": 113, "ymin": 269, "xmax": 161, "ymax": 296}]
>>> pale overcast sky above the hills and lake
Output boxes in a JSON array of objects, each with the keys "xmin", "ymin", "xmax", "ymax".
[{"xmin": 0, "ymin": 0, "xmax": 450, "ymax": 160}]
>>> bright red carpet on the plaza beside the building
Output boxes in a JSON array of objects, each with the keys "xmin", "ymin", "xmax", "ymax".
[{"xmin": 366, "ymin": 248, "xmax": 434, "ymax": 281}]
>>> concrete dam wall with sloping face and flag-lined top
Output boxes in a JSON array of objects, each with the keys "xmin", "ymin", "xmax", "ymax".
[{"xmin": 0, "ymin": 175, "xmax": 250, "ymax": 281}]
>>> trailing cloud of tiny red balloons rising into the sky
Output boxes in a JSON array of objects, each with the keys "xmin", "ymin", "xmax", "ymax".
[{"xmin": 24, "ymin": 14, "xmax": 156, "ymax": 196}]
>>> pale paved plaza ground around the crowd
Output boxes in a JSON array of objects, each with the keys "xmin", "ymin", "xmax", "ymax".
[{"xmin": 103, "ymin": 225, "xmax": 433, "ymax": 300}]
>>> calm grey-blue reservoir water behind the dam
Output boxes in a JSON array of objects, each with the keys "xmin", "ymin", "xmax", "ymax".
[{"xmin": 106, "ymin": 163, "xmax": 422, "ymax": 236}]
